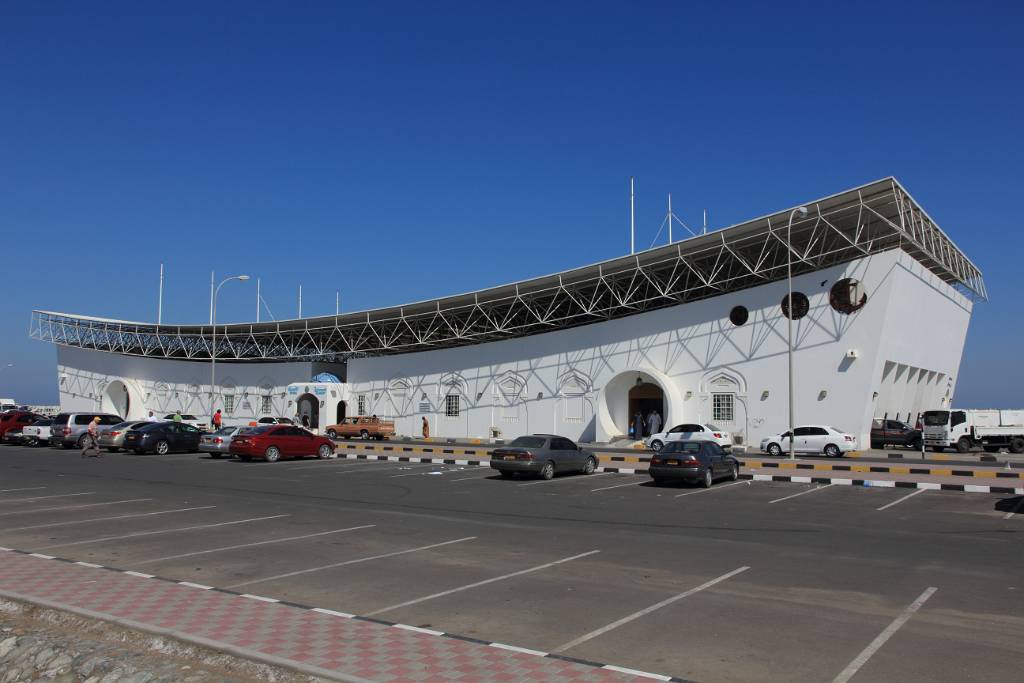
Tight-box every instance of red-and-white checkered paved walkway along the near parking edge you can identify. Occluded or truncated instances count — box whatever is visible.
[0,549,677,683]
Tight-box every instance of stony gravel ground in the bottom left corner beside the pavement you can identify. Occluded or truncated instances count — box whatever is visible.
[0,598,323,683]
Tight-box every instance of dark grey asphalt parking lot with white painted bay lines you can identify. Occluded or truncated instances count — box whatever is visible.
[0,446,1024,681]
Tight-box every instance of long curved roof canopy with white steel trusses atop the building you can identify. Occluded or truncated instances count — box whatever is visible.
[30,177,986,361]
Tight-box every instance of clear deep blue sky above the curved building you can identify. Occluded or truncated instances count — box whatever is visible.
[0,2,1024,407]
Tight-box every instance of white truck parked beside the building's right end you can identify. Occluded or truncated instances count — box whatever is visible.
[924,410,1024,453]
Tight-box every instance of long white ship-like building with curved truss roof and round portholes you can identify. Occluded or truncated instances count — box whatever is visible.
[31,178,986,444]
